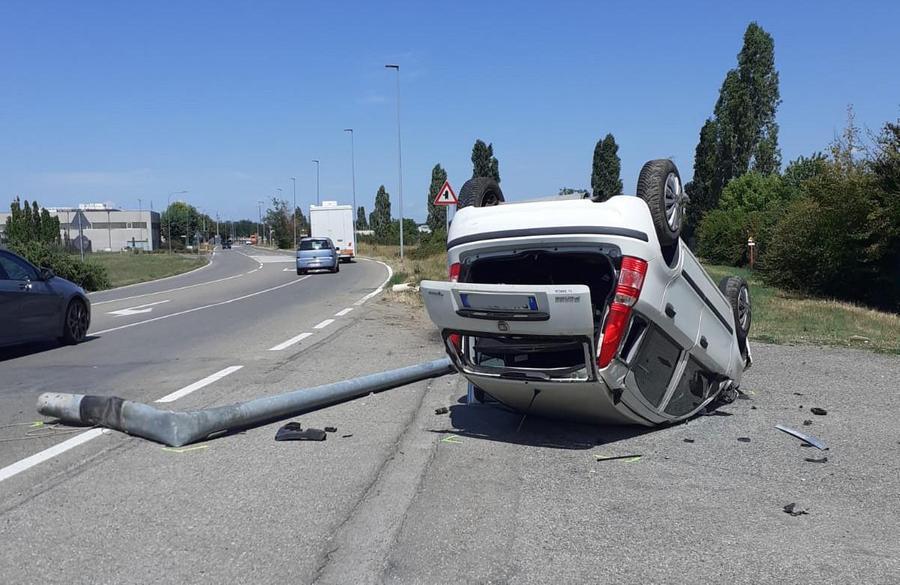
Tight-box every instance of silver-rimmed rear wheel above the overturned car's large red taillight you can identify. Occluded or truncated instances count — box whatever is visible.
[637,159,684,248]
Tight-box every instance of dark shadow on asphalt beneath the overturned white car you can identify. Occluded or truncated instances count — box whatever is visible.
[431,403,656,449]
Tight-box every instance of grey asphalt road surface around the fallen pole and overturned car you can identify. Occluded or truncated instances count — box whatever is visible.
[0,251,900,584]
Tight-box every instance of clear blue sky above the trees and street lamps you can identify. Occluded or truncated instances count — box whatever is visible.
[0,0,900,220]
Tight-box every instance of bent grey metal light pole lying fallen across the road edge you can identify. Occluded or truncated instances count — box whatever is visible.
[38,358,456,447]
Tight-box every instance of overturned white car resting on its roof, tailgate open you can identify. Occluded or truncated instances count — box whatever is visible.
[421,160,751,425]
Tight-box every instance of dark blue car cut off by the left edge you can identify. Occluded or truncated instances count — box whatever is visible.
[0,250,91,345]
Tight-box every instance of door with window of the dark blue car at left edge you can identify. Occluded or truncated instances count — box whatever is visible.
[0,252,62,341]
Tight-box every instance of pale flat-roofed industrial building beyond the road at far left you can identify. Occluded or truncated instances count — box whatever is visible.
[0,203,160,252]
